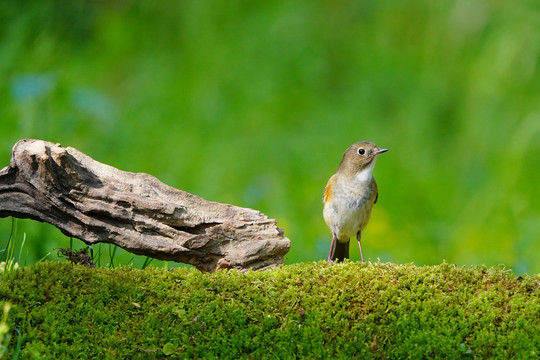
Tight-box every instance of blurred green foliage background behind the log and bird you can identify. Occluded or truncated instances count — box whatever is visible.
[0,0,540,273]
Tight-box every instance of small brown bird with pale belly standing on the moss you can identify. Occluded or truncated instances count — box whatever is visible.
[323,141,388,262]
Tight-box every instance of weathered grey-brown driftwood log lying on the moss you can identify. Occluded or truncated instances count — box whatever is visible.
[0,139,290,271]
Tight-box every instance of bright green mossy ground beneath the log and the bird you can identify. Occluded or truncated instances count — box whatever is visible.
[0,262,540,359]
